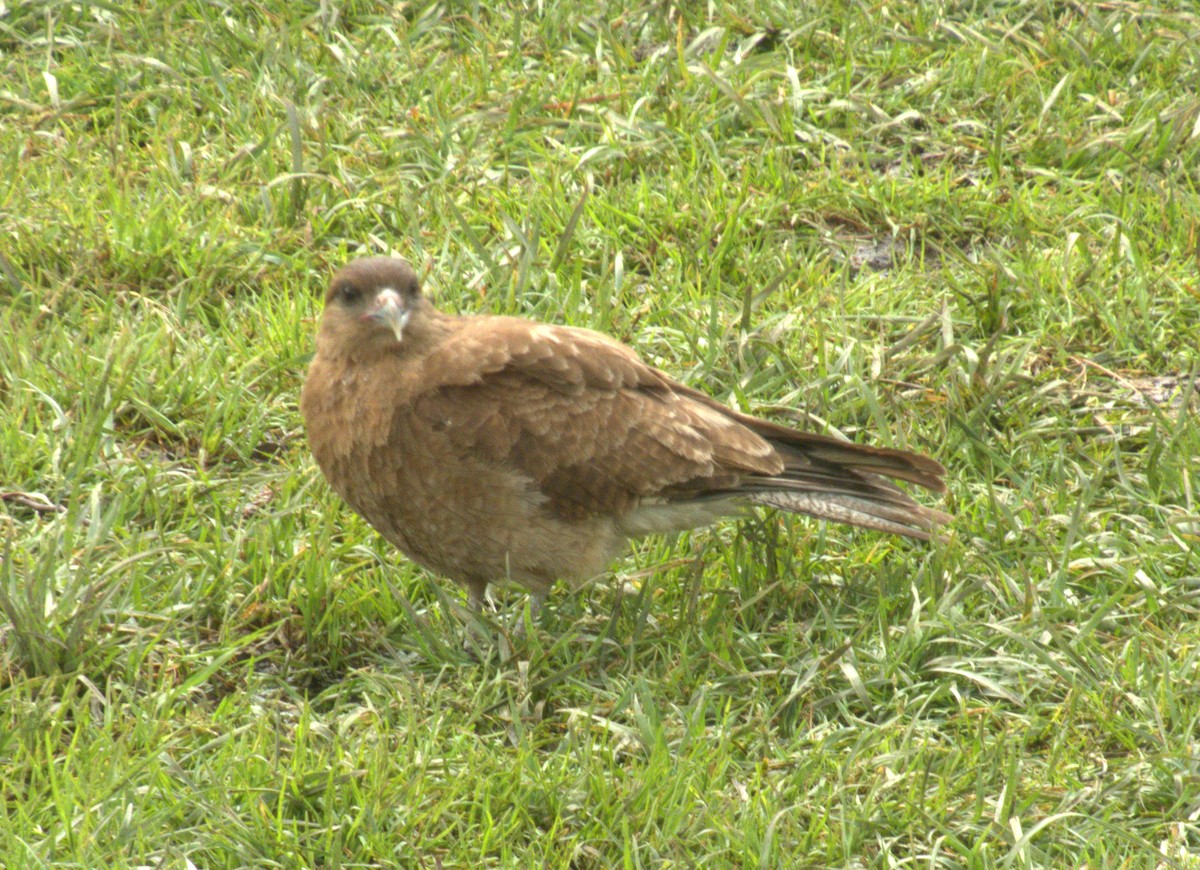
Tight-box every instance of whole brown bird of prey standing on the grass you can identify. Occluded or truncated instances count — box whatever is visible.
[300,257,950,611]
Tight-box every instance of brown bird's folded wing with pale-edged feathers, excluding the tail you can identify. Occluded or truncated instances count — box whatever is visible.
[413,318,784,517]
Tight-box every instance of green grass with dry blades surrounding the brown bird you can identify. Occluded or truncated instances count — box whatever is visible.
[0,0,1200,868]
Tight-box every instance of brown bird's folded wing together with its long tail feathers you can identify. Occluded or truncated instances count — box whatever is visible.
[413,318,948,538]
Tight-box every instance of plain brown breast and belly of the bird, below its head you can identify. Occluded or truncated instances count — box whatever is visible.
[301,350,623,588]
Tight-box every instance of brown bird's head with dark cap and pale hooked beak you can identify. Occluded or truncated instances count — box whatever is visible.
[320,257,427,352]
